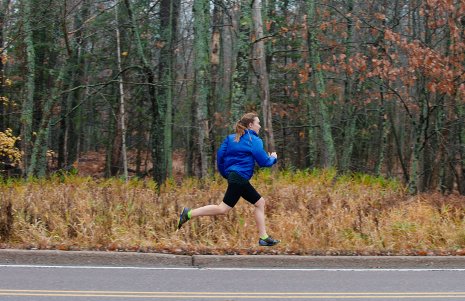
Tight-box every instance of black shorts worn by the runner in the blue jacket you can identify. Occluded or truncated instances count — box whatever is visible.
[223,172,262,208]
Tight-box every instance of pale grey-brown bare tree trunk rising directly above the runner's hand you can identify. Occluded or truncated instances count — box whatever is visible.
[252,0,275,152]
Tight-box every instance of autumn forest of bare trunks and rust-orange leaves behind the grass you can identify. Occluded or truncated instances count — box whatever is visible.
[0,0,465,195]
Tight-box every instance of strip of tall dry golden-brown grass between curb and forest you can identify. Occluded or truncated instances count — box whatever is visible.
[0,170,465,255]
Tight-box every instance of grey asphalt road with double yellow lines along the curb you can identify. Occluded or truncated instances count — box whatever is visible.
[0,264,465,301]
